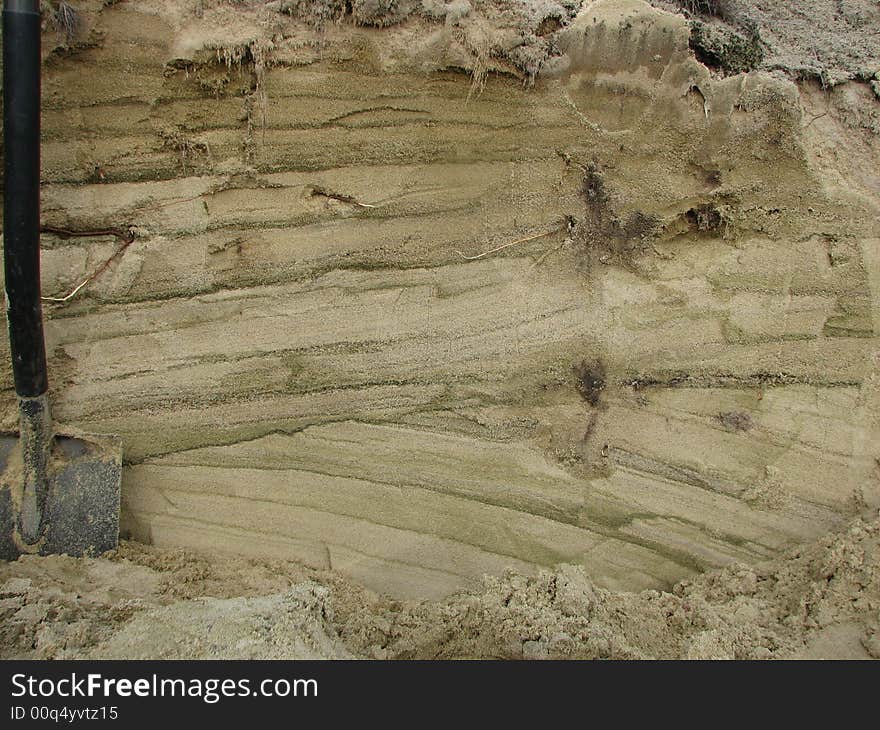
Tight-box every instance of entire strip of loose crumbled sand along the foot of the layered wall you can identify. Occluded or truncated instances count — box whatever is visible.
[0,510,880,659]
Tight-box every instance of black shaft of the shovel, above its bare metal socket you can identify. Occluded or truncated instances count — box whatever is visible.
[3,0,48,398]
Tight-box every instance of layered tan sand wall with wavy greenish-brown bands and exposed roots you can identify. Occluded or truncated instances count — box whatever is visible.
[2,0,880,597]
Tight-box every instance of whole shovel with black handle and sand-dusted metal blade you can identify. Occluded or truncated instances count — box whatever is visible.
[0,0,122,560]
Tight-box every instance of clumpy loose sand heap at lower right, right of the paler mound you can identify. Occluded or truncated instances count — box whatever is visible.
[343,510,880,659]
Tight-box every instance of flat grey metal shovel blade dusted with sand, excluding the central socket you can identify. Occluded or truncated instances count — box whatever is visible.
[0,434,122,560]
